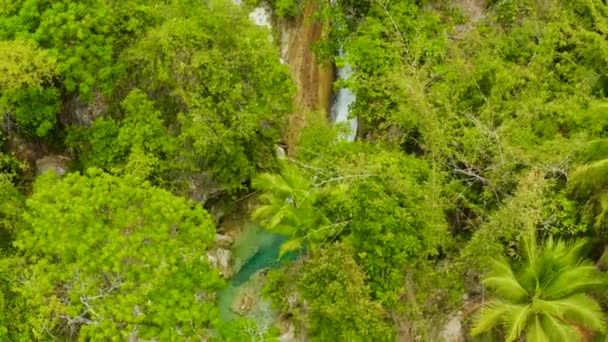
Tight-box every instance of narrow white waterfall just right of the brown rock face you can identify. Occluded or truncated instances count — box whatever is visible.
[331,49,359,141]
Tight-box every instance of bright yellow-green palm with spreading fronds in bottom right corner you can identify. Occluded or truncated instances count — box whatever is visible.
[472,234,606,342]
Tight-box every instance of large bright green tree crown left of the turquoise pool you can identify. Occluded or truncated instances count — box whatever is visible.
[11,169,222,339]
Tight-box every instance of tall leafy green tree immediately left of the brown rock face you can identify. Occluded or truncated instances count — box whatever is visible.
[125,2,293,189]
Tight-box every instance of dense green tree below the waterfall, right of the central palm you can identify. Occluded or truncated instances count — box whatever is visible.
[341,152,446,306]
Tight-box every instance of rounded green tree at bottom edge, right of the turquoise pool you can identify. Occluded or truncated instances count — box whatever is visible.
[264,243,395,341]
